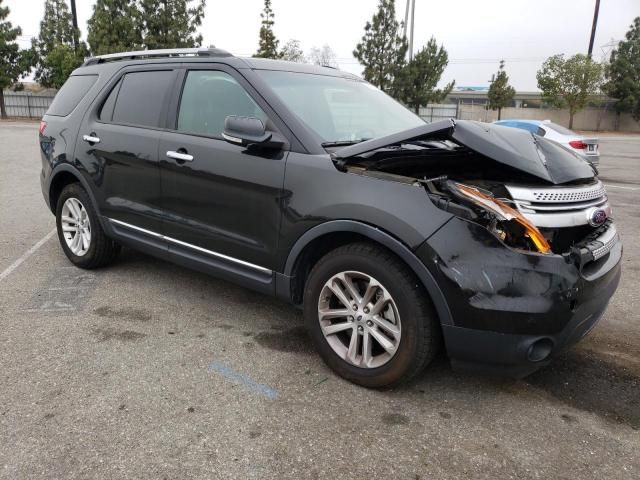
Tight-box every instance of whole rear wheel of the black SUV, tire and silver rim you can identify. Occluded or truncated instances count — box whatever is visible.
[56,183,120,268]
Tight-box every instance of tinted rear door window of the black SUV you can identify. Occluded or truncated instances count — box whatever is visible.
[107,70,174,127]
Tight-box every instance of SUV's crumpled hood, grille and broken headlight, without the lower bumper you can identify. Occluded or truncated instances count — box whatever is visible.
[332,120,617,265]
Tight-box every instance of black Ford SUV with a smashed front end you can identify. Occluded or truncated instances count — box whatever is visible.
[39,49,622,387]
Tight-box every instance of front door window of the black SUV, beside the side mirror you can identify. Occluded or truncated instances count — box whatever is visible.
[176,70,267,138]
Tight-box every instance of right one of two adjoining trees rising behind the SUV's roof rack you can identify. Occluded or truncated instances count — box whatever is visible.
[140,0,205,50]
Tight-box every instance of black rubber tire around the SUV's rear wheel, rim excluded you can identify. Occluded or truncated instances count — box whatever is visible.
[56,183,120,269]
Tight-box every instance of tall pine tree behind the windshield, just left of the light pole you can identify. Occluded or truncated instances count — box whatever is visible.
[353,0,408,97]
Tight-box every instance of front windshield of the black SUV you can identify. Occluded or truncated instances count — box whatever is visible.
[262,70,425,144]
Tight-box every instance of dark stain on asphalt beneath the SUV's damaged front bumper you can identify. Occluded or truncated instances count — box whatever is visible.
[525,351,640,430]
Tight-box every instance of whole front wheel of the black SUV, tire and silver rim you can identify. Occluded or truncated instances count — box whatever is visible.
[304,243,440,387]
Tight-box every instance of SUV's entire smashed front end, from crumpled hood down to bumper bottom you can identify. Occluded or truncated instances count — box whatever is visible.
[332,121,622,376]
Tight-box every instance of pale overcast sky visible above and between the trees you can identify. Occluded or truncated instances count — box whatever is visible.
[4,0,640,91]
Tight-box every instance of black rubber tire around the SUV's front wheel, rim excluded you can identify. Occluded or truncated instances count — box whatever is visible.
[304,243,441,388]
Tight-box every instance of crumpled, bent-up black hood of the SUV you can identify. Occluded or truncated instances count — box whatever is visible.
[332,120,597,185]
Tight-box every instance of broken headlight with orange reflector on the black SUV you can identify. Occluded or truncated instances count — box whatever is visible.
[446,181,551,253]
